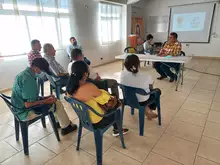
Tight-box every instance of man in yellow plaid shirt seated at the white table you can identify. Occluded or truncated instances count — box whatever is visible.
[154,32,182,82]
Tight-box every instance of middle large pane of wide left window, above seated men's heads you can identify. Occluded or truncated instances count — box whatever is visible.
[27,16,58,48]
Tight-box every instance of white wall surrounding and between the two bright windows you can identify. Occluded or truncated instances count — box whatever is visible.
[0,0,127,90]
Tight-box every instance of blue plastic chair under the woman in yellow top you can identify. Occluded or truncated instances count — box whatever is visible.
[64,96,126,165]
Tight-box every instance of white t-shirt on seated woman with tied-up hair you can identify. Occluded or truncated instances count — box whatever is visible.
[120,68,153,102]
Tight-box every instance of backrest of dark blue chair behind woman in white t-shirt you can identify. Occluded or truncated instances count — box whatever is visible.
[119,84,147,108]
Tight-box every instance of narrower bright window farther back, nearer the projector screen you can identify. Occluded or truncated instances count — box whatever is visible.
[100,3,122,45]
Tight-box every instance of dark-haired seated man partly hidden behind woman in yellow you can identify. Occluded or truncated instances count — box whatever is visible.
[68,49,119,99]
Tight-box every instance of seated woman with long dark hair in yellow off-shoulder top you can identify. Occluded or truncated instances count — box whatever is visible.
[66,61,128,136]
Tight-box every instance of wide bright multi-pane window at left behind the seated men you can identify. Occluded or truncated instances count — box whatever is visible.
[0,0,71,56]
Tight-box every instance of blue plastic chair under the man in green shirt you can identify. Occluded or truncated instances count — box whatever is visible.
[0,93,60,155]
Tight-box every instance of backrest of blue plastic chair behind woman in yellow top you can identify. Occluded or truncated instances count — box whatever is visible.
[64,96,93,131]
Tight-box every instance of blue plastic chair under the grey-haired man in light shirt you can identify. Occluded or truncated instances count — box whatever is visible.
[46,72,68,99]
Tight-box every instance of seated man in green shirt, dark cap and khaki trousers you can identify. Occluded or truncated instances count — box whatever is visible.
[11,58,77,135]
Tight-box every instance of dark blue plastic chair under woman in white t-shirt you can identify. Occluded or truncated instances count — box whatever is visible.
[119,84,161,136]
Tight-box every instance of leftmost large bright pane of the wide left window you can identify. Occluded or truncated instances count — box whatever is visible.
[0,15,30,55]
